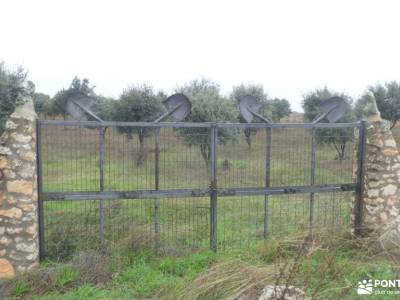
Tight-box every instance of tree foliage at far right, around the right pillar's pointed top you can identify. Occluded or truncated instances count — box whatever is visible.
[355,81,400,128]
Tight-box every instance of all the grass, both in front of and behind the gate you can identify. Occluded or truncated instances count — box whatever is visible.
[0,126,399,300]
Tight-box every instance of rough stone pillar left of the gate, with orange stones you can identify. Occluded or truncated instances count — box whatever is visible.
[0,92,39,278]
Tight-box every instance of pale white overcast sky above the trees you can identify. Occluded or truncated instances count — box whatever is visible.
[0,0,400,111]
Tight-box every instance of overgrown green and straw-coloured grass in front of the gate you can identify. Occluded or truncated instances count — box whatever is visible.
[0,232,400,300]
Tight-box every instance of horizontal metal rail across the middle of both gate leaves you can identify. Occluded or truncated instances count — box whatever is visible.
[41,184,356,201]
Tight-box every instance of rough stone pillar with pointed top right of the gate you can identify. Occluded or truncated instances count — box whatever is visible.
[354,94,400,249]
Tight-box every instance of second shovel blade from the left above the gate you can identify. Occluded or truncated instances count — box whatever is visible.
[154,93,192,123]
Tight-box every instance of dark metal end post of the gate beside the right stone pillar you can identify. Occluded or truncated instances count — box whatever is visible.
[354,121,367,235]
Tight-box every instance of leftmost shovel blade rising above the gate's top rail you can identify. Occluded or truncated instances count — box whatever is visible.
[65,92,103,122]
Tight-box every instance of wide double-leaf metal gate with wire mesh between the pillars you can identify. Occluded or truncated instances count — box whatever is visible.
[37,121,362,258]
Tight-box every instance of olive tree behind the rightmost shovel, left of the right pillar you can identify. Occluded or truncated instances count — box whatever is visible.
[302,87,355,161]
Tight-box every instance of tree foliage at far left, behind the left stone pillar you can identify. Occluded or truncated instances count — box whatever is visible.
[0,62,26,135]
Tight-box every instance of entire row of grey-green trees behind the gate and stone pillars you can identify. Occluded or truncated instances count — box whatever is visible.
[0,63,400,163]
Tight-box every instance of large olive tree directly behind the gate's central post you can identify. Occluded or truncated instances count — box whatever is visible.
[177,79,238,166]
